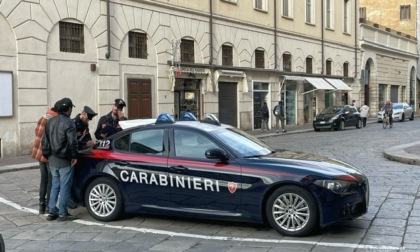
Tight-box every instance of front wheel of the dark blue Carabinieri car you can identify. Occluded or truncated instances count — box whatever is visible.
[266,186,318,236]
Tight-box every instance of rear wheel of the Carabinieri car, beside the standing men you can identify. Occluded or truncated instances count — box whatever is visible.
[85,177,124,222]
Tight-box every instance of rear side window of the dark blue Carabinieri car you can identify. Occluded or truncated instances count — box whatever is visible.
[114,129,164,155]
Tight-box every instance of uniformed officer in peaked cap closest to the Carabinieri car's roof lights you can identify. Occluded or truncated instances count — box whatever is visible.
[95,99,127,140]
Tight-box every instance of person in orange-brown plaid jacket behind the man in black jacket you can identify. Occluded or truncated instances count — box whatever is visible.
[31,107,58,214]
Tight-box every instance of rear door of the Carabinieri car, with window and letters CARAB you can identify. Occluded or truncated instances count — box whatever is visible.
[109,128,170,208]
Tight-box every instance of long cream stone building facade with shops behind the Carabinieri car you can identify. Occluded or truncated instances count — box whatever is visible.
[0,0,411,157]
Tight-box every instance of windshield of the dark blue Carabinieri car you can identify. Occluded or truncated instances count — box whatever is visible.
[212,128,273,157]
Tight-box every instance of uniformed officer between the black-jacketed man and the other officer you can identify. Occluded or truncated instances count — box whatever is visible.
[73,106,97,150]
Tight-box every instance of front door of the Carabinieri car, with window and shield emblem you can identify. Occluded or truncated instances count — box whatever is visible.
[168,128,241,216]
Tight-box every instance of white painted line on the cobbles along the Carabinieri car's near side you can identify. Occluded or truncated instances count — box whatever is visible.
[0,197,404,250]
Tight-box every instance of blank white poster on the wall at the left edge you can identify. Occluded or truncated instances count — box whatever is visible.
[0,72,13,117]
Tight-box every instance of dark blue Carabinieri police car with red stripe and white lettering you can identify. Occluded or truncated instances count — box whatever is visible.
[73,114,369,236]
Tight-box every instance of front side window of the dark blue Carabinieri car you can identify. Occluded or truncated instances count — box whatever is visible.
[174,129,218,158]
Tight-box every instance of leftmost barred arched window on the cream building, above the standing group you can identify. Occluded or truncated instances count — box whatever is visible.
[59,22,85,53]
